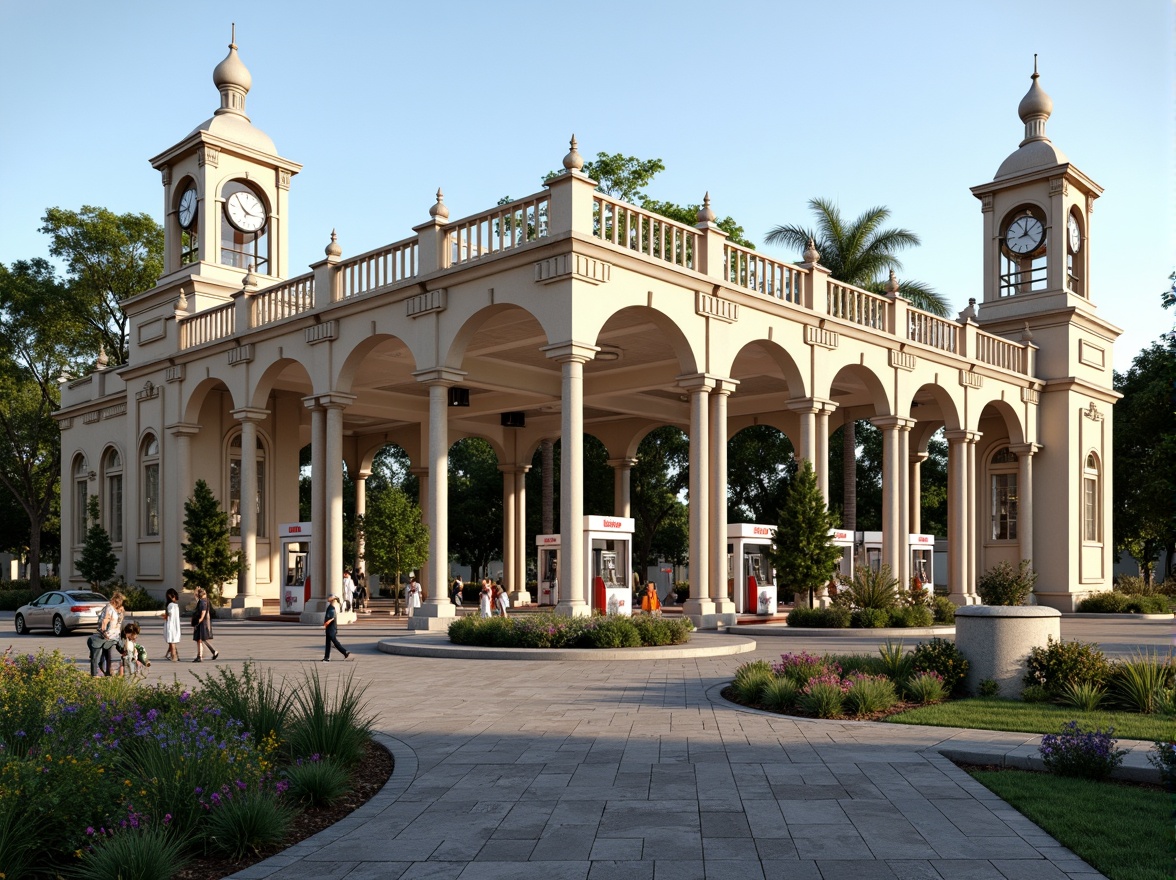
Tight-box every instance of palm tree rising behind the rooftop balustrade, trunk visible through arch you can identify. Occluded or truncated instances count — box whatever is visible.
[766,199,948,531]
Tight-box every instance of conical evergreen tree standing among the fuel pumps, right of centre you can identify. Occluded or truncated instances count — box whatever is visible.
[771,459,841,605]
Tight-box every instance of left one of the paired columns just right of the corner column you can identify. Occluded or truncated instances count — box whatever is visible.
[677,373,715,628]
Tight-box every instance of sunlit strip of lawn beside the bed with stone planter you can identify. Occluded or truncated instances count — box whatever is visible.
[884,696,1172,741]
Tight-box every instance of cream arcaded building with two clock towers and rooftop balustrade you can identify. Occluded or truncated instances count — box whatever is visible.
[58,39,1120,628]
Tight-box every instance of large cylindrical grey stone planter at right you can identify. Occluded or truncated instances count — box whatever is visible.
[956,605,1062,700]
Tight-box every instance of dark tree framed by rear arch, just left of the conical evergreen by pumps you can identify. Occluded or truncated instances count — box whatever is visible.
[727,425,794,522]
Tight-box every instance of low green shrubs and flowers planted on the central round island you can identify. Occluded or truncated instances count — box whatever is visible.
[449,614,694,648]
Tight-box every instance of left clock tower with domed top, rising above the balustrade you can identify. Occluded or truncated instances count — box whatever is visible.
[151,33,301,291]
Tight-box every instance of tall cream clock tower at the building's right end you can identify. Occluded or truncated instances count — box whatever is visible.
[971,59,1121,611]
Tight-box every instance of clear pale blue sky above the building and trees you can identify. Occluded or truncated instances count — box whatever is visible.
[0,0,1176,369]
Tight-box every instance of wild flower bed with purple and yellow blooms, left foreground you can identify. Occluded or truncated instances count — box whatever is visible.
[0,651,372,880]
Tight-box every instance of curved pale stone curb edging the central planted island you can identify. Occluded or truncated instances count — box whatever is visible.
[375,633,756,662]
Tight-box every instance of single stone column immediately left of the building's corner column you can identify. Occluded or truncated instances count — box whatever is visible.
[408,369,465,631]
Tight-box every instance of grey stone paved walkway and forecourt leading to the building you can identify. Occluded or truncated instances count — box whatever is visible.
[4,618,1171,880]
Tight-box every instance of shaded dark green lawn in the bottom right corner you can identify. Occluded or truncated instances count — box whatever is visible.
[968,769,1174,880]
